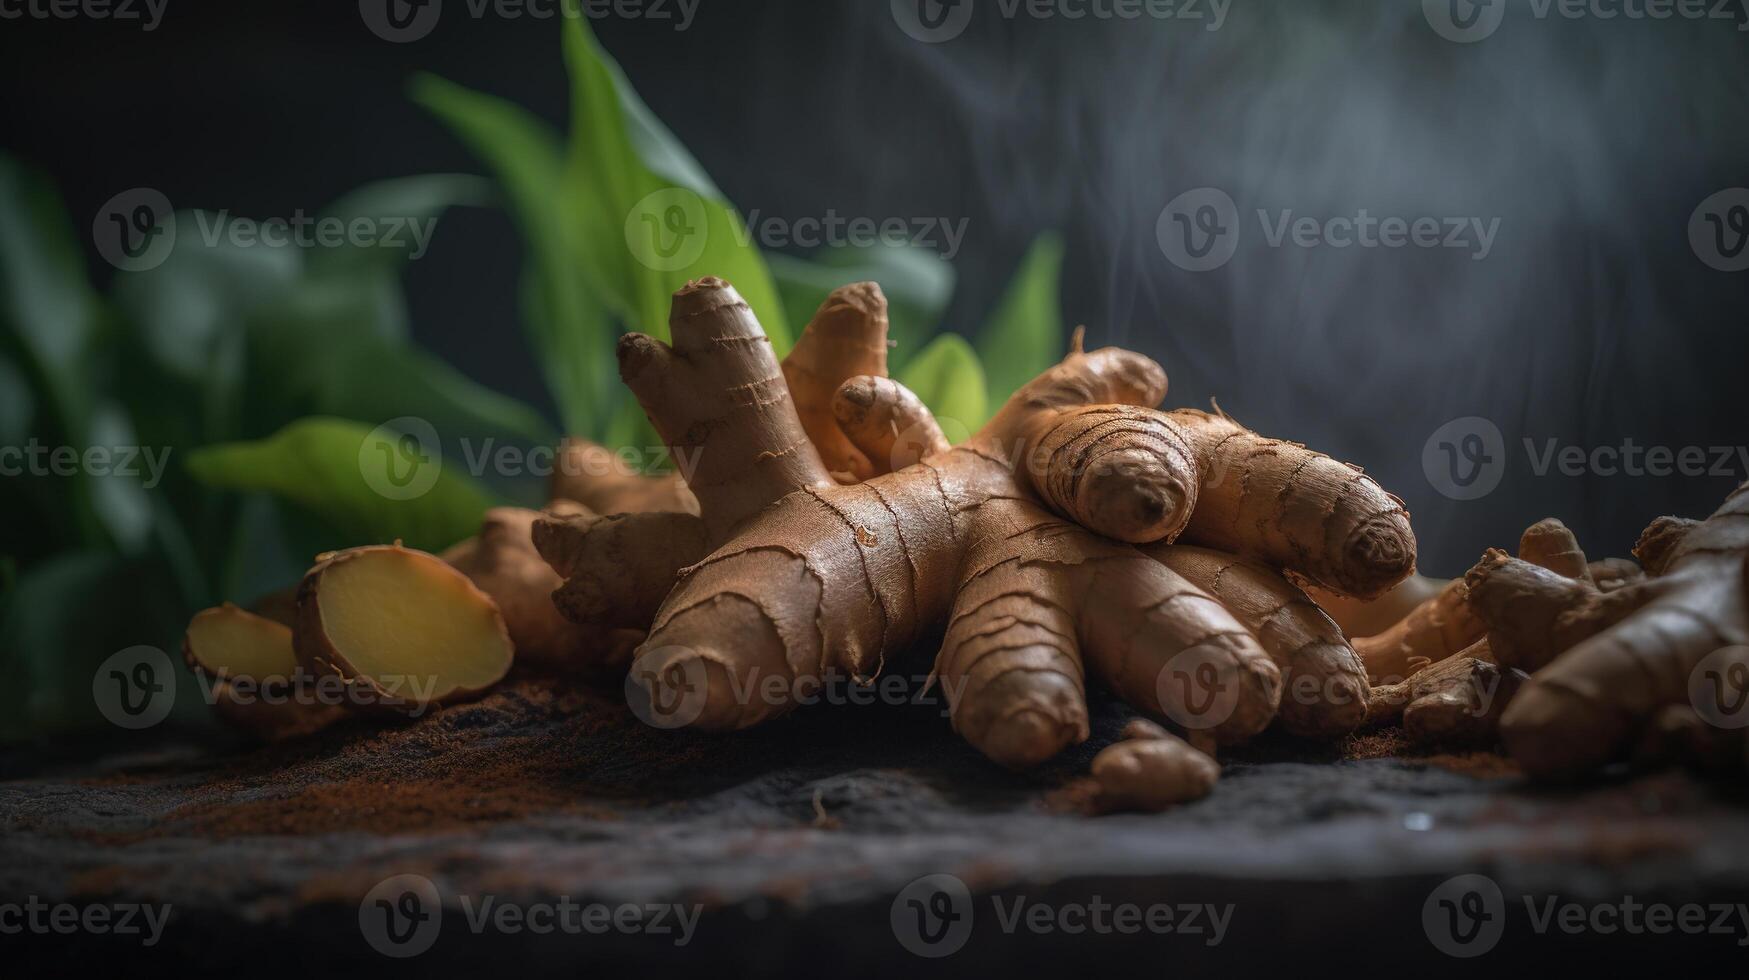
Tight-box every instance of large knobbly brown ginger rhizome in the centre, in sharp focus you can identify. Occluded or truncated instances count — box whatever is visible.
[533,278,1415,767]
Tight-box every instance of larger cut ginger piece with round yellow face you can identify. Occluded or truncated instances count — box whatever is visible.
[294,543,514,714]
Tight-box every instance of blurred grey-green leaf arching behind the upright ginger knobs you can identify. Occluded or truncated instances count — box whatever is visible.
[766,245,953,366]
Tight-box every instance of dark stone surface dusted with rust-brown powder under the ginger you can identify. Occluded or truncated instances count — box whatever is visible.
[0,683,1749,977]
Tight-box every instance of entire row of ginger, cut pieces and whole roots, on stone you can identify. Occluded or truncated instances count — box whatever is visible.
[184,278,1749,810]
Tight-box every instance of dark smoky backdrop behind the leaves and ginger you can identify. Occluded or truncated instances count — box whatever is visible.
[0,0,1749,574]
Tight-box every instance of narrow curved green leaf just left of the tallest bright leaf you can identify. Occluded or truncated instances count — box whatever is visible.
[413,75,619,434]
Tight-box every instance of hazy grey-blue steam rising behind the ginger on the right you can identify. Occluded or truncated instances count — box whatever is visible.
[850,0,1749,574]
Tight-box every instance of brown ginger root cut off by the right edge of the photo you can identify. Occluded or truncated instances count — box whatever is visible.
[1466,483,1749,777]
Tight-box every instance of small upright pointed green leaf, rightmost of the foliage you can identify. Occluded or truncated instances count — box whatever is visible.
[978,235,1069,406]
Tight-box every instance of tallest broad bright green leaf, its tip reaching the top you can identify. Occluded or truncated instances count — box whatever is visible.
[563,18,791,355]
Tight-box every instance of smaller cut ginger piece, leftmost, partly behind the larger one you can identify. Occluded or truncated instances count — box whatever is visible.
[182,602,345,742]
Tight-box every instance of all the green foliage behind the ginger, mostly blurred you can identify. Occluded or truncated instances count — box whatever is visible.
[0,18,1065,740]
